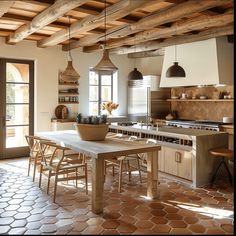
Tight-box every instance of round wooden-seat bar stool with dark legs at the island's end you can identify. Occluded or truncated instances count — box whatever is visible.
[210,148,234,185]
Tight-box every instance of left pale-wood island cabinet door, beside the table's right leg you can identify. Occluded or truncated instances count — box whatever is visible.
[162,147,178,175]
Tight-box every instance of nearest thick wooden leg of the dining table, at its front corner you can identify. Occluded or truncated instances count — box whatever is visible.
[92,157,104,214]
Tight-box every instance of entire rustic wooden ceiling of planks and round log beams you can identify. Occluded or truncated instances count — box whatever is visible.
[0,0,234,57]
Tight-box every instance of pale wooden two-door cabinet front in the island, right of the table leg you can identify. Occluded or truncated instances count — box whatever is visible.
[158,146,192,180]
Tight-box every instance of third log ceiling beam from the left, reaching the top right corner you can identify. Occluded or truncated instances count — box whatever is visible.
[65,0,232,51]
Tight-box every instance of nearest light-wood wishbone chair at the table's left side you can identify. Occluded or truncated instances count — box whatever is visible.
[39,141,88,202]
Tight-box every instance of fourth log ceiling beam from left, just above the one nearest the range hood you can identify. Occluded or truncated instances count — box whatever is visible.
[106,9,234,49]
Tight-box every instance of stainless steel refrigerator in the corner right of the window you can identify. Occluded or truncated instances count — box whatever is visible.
[128,75,171,122]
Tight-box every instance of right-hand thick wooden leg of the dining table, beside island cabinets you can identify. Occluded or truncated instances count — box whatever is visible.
[147,152,158,198]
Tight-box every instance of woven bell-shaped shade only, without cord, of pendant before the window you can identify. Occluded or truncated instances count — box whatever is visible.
[93,49,118,72]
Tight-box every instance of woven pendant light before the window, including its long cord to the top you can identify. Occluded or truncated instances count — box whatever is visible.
[92,0,118,72]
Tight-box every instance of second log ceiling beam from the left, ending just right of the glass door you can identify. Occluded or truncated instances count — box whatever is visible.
[38,0,159,47]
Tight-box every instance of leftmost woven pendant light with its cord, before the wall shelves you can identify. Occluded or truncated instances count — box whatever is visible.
[61,16,80,83]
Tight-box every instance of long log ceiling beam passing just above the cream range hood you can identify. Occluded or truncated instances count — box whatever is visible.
[109,24,234,55]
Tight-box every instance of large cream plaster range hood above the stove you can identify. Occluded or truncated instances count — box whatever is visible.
[160,36,234,87]
